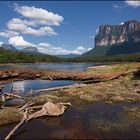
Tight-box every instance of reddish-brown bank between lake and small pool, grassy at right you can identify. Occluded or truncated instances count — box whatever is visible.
[0,63,140,84]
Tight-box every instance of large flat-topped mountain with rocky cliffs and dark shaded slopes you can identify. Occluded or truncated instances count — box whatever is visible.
[82,20,140,56]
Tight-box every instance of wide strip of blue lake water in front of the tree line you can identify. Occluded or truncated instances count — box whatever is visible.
[0,63,99,71]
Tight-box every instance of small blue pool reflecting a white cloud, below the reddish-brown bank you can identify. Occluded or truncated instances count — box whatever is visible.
[1,80,76,96]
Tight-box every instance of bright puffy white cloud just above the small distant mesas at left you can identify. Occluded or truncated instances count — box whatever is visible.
[8,36,36,47]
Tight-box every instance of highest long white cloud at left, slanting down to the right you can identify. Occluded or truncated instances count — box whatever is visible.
[15,4,64,26]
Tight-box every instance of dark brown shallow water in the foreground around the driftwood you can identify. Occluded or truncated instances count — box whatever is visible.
[0,103,140,139]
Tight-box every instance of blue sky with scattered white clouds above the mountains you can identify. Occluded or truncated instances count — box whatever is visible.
[0,0,140,55]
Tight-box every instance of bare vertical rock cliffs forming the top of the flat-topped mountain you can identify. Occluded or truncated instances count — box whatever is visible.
[95,20,140,46]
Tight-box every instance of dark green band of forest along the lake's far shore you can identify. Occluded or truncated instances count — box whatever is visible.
[0,48,140,63]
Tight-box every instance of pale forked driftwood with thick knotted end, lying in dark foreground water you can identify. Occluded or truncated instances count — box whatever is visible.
[5,102,71,140]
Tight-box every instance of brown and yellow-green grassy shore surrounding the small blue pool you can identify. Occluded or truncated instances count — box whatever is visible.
[0,63,140,126]
